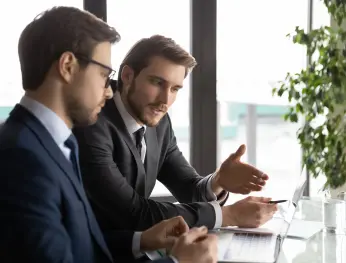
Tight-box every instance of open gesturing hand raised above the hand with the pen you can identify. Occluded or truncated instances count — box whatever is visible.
[212,144,269,194]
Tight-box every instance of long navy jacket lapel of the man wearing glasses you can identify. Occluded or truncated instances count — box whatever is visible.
[11,105,112,259]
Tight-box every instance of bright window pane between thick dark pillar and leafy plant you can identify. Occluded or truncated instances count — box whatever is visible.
[217,0,308,202]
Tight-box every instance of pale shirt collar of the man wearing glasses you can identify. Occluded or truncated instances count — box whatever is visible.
[20,96,71,145]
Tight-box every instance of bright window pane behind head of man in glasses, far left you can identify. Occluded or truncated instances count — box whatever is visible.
[0,0,83,122]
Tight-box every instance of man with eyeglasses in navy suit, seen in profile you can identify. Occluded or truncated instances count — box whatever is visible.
[0,7,216,263]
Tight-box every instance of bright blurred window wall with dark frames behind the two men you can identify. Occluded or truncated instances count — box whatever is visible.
[0,0,330,200]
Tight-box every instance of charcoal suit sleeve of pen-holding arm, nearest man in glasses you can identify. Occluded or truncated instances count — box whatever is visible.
[74,116,215,231]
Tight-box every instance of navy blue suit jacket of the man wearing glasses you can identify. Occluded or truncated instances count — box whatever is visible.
[0,105,172,263]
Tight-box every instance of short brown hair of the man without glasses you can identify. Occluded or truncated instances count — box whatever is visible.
[116,35,197,91]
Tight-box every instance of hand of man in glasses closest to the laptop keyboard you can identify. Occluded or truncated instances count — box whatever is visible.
[171,227,217,263]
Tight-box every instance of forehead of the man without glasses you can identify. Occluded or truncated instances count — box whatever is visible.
[141,56,186,85]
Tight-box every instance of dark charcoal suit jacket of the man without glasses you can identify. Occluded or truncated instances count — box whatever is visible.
[74,97,219,231]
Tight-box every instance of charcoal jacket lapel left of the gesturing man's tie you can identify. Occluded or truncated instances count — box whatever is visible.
[103,99,146,196]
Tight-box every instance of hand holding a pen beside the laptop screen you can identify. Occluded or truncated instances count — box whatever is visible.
[222,196,278,227]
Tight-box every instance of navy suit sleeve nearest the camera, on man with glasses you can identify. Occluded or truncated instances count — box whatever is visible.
[0,149,73,263]
